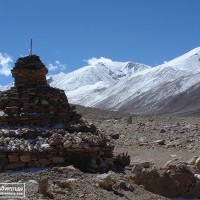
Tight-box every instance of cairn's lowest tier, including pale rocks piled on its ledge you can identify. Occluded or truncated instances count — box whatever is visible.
[0,126,114,172]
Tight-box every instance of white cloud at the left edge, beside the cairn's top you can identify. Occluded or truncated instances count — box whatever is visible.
[0,53,13,76]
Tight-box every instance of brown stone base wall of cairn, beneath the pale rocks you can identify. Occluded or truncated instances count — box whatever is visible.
[0,147,113,172]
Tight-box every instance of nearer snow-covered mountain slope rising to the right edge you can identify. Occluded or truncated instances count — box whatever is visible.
[91,48,200,114]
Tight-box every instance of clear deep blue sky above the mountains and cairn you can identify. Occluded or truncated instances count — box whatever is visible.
[0,0,200,85]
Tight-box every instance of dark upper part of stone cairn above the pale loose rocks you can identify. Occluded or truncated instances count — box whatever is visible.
[0,55,80,126]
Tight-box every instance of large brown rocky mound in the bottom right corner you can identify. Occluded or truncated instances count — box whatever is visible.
[132,164,200,198]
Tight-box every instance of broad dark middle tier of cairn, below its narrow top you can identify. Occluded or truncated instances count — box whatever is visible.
[0,87,81,126]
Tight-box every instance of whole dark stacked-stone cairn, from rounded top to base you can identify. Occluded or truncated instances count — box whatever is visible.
[0,55,114,172]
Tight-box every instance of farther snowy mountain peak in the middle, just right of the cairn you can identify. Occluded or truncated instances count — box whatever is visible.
[49,58,149,106]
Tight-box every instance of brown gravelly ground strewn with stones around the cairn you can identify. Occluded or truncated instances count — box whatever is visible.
[0,106,200,200]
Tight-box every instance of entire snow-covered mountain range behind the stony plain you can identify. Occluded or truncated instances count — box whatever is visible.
[0,47,200,115]
